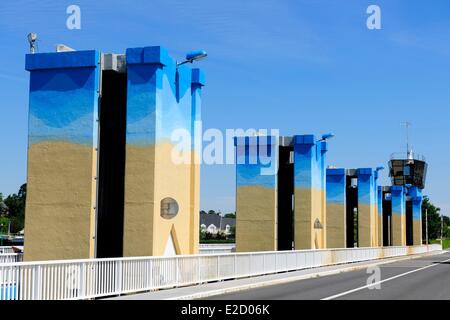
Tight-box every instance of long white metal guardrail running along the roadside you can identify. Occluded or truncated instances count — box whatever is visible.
[0,245,441,300]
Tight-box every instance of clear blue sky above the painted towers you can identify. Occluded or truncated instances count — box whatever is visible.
[0,0,450,214]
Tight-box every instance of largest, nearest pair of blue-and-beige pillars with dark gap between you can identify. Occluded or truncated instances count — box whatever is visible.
[24,46,205,261]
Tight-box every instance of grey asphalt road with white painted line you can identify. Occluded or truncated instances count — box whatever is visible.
[210,252,450,300]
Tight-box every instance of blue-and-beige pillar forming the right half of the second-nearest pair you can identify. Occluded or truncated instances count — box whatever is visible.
[294,135,327,249]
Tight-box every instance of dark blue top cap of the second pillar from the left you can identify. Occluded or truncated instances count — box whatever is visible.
[126,46,174,66]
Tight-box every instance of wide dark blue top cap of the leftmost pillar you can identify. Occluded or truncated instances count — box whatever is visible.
[25,50,99,71]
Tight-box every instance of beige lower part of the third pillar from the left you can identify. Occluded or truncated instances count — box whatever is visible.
[236,186,277,252]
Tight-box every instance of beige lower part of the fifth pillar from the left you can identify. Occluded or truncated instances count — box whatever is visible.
[327,203,347,248]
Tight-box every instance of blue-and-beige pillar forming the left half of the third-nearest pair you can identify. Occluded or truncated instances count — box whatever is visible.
[326,169,347,248]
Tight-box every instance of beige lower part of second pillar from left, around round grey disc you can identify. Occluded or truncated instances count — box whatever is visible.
[124,143,199,256]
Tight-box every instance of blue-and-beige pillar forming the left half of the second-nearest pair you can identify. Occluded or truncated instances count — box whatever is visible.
[235,137,278,252]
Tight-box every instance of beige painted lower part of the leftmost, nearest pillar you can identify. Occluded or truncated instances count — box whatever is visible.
[24,141,97,261]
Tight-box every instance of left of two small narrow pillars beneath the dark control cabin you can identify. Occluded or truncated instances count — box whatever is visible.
[391,186,406,246]
